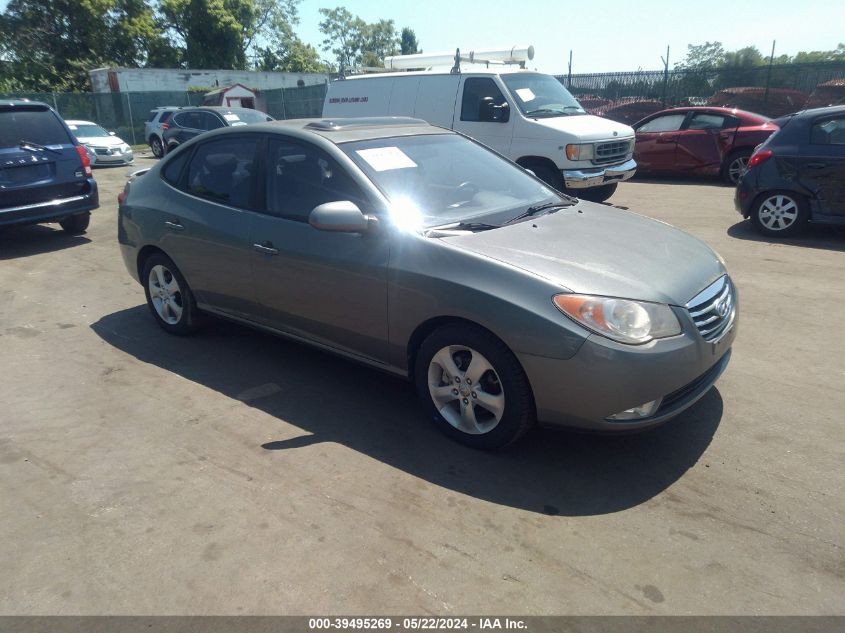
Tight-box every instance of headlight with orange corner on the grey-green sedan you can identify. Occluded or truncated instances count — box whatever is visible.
[553,295,681,345]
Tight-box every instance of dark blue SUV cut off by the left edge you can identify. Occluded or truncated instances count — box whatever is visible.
[0,100,100,235]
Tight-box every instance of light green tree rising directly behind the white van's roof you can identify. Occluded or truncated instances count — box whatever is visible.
[320,7,399,70]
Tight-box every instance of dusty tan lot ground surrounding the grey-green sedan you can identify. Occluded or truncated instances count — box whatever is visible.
[0,158,845,614]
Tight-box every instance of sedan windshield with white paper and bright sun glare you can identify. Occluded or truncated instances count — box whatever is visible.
[340,134,569,229]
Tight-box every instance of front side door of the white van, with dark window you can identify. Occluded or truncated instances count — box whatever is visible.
[453,77,513,156]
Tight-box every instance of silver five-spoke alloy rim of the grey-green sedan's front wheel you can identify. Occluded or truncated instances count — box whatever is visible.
[428,345,505,435]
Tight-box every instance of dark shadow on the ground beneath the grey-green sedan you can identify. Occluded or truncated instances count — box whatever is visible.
[91,305,722,516]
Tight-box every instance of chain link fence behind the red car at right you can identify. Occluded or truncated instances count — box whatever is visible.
[557,62,845,123]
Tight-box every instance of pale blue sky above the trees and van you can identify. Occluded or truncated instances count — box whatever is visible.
[297,0,845,74]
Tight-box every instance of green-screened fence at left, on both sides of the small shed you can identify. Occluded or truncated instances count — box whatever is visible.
[0,84,327,145]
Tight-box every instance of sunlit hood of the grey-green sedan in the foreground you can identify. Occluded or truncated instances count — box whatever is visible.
[441,201,725,305]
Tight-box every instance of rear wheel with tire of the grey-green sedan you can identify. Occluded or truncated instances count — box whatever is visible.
[141,253,198,336]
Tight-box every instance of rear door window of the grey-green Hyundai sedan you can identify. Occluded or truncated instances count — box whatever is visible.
[187,135,258,209]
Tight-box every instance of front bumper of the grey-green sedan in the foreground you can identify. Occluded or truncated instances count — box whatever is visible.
[517,308,738,432]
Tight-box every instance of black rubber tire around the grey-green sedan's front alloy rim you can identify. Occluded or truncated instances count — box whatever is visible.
[414,324,536,450]
